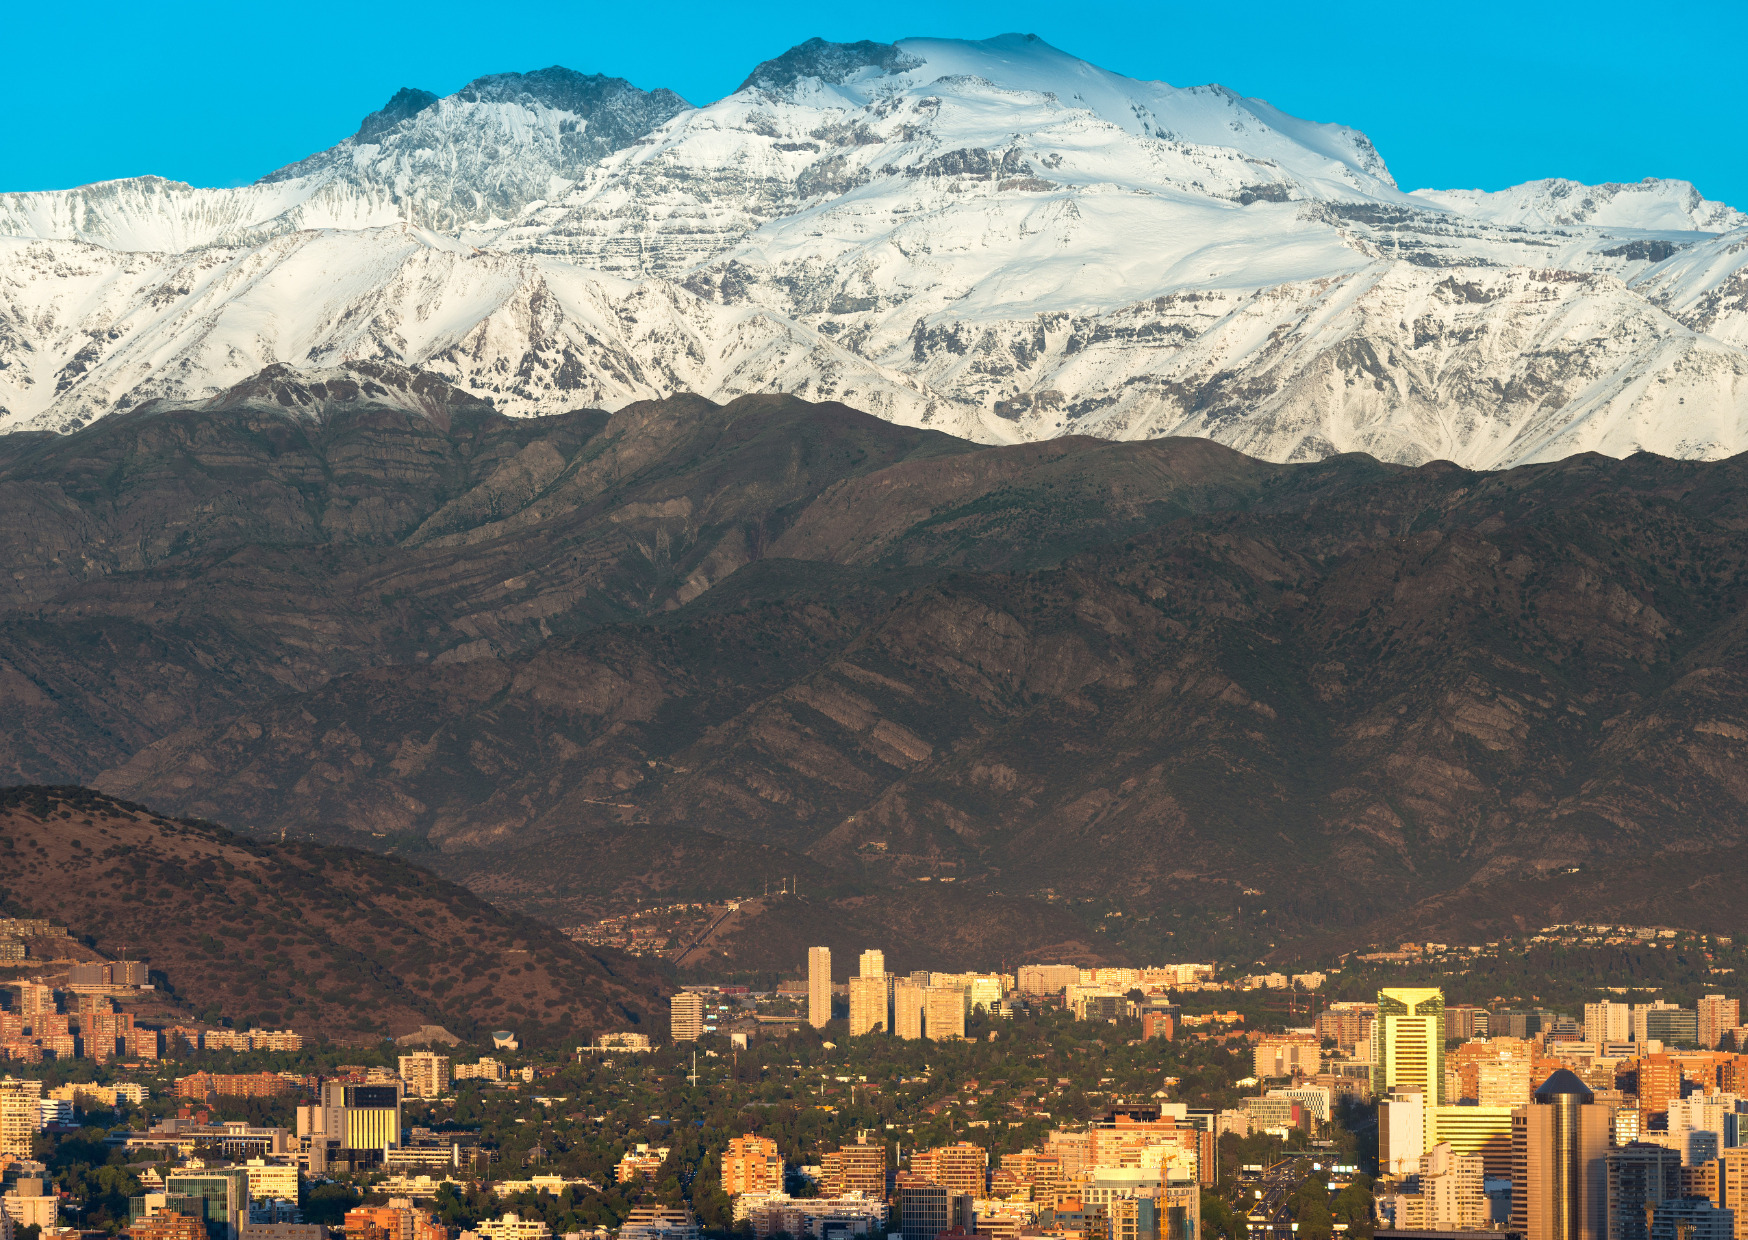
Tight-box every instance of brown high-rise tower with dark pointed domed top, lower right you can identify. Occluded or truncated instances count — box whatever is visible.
[1512,1069,1613,1240]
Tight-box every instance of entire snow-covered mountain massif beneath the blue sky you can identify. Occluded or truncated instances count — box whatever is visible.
[0,35,1748,465]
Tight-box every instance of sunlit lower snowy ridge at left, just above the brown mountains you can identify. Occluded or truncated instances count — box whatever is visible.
[0,224,930,435]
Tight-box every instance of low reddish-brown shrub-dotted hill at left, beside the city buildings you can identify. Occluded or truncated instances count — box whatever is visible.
[0,787,661,1042]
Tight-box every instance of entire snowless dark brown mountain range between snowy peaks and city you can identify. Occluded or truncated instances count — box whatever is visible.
[0,377,1748,943]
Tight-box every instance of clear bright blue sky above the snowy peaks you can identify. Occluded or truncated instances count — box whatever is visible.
[0,0,1748,210]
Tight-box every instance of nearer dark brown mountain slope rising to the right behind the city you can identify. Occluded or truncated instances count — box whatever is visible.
[95,458,1748,943]
